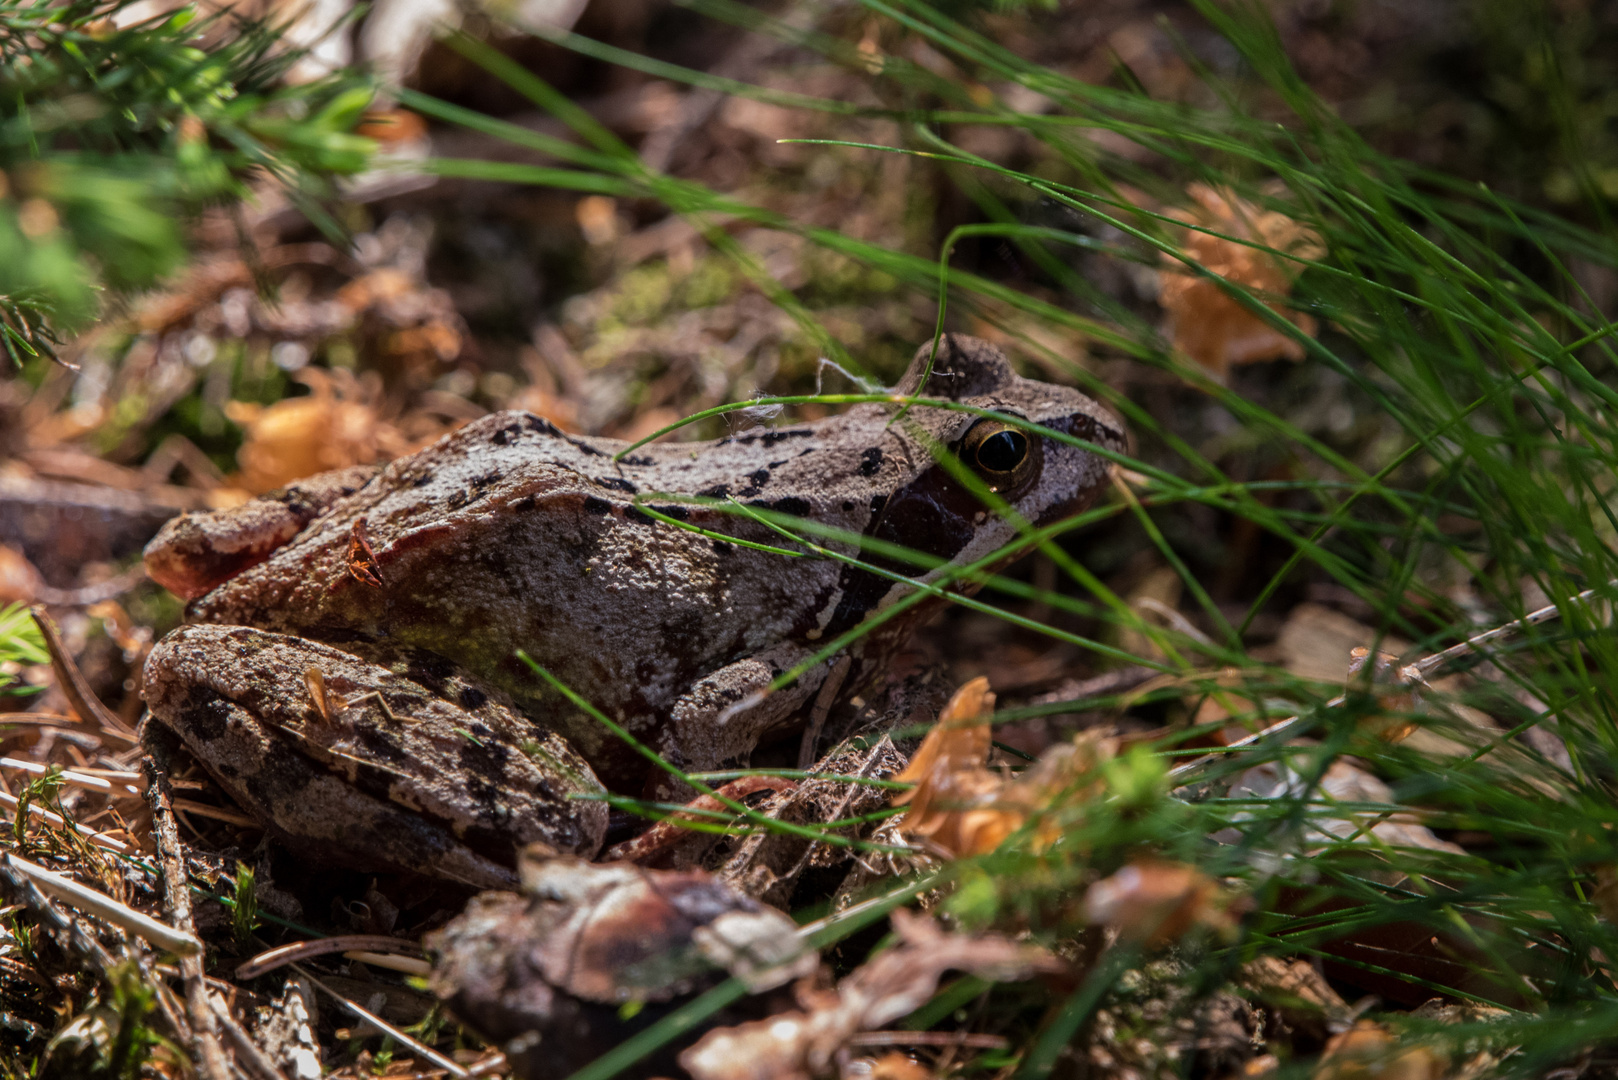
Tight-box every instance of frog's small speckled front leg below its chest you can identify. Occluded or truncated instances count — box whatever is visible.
[667,641,835,772]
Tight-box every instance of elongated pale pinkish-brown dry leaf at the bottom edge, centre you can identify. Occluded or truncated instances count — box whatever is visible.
[680,910,1063,1080]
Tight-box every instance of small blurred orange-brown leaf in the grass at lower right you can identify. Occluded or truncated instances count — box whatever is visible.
[1084,858,1236,949]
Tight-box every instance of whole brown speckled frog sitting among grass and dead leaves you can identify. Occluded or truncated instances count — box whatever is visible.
[146,337,1123,886]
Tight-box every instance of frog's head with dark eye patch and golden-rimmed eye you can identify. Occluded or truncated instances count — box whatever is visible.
[828,334,1126,631]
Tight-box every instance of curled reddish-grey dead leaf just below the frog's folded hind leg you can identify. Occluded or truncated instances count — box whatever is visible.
[426,844,819,1080]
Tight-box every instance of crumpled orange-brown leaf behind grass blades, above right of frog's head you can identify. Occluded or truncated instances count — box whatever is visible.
[1158,183,1325,377]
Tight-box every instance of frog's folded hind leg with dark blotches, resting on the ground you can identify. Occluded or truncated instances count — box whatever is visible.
[146,625,607,887]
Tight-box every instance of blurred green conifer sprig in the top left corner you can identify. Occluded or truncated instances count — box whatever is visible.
[0,0,375,351]
